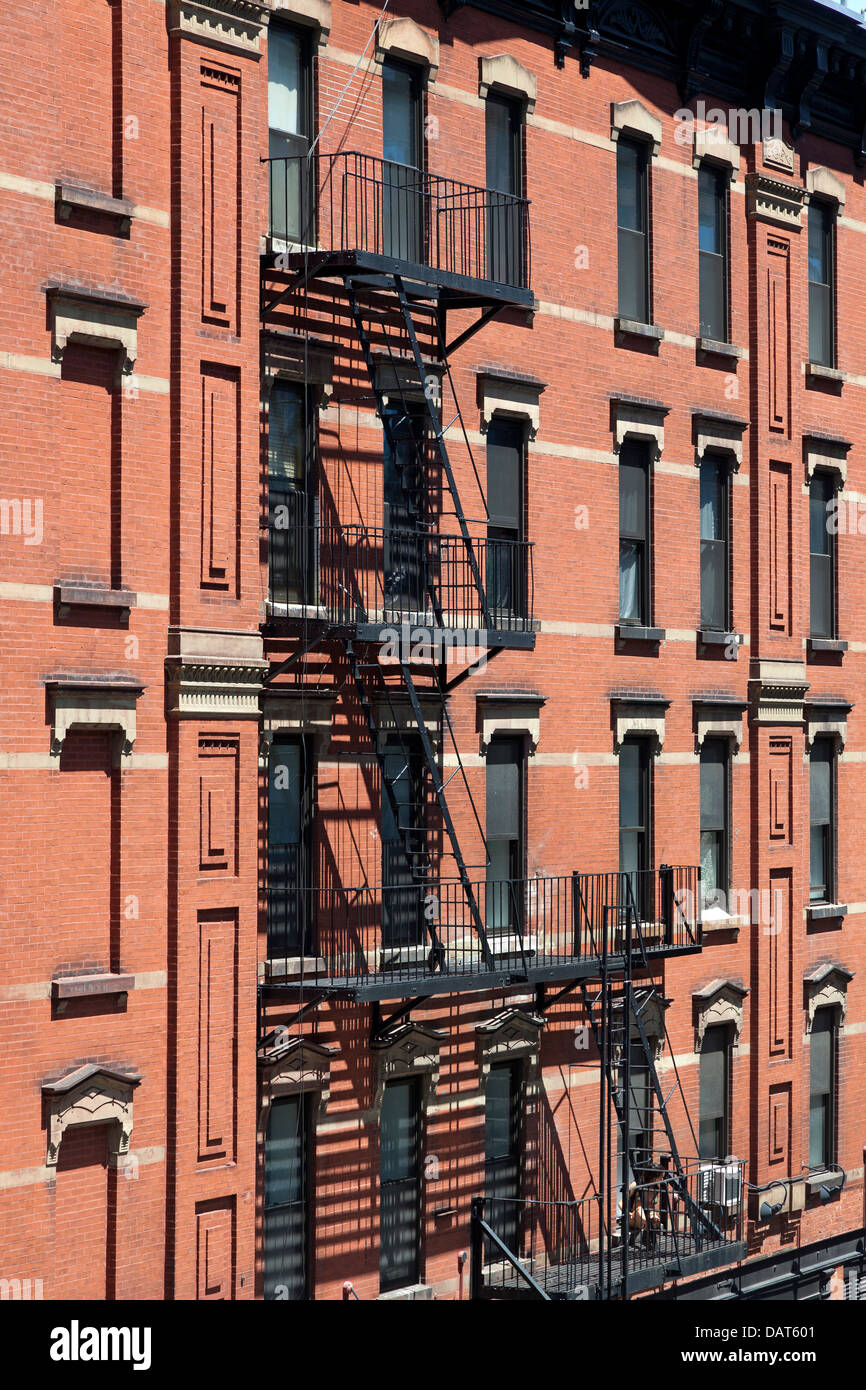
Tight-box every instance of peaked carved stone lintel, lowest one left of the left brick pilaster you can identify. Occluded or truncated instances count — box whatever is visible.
[42,1063,142,1168]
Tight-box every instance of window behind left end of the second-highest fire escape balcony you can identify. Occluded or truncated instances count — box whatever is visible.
[268,381,316,605]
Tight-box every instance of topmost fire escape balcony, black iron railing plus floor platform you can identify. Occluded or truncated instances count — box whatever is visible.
[265,150,532,307]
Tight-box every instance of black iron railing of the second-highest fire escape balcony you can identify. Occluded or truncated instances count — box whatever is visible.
[268,511,534,632]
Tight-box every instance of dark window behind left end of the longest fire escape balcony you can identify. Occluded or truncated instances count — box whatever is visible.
[267,738,313,958]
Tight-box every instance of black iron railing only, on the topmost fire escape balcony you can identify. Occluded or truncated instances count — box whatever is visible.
[267,150,530,289]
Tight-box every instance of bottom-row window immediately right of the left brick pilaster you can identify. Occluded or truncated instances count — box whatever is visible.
[264,1095,313,1300]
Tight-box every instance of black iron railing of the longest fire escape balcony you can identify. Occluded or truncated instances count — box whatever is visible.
[267,860,701,988]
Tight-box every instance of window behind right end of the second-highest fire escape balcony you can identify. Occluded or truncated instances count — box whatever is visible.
[487,418,527,627]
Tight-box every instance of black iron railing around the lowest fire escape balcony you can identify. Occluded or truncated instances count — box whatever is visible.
[471,1158,744,1298]
